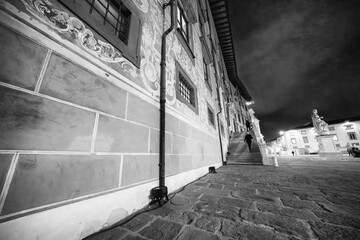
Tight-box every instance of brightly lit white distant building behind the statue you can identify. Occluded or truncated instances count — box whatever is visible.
[270,116,360,155]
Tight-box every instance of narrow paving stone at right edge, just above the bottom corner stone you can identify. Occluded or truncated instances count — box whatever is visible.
[314,211,360,228]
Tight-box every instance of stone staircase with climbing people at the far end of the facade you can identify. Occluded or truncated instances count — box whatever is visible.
[226,131,263,165]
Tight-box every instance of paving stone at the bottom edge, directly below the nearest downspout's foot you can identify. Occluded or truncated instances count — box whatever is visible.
[139,219,182,240]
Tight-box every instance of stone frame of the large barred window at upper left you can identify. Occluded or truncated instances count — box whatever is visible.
[60,0,143,68]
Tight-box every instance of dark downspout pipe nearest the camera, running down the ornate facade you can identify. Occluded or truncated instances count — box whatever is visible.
[150,0,177,205]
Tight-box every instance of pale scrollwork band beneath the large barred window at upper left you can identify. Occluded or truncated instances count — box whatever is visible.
[21,0,136,76]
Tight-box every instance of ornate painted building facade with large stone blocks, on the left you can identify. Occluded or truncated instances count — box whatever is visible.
[0,0,251,240]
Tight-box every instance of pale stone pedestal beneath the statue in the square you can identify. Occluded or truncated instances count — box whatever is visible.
[316,134,342,160]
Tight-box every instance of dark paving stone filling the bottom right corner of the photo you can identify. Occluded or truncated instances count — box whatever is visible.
[310,222,360,240]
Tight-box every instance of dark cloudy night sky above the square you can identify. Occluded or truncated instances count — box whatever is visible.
[228,0,360,141]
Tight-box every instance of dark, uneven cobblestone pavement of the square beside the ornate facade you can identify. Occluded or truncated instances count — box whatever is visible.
[87,158,360,240]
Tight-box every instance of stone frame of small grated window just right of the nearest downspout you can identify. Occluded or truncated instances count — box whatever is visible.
[175,62,199,114]
